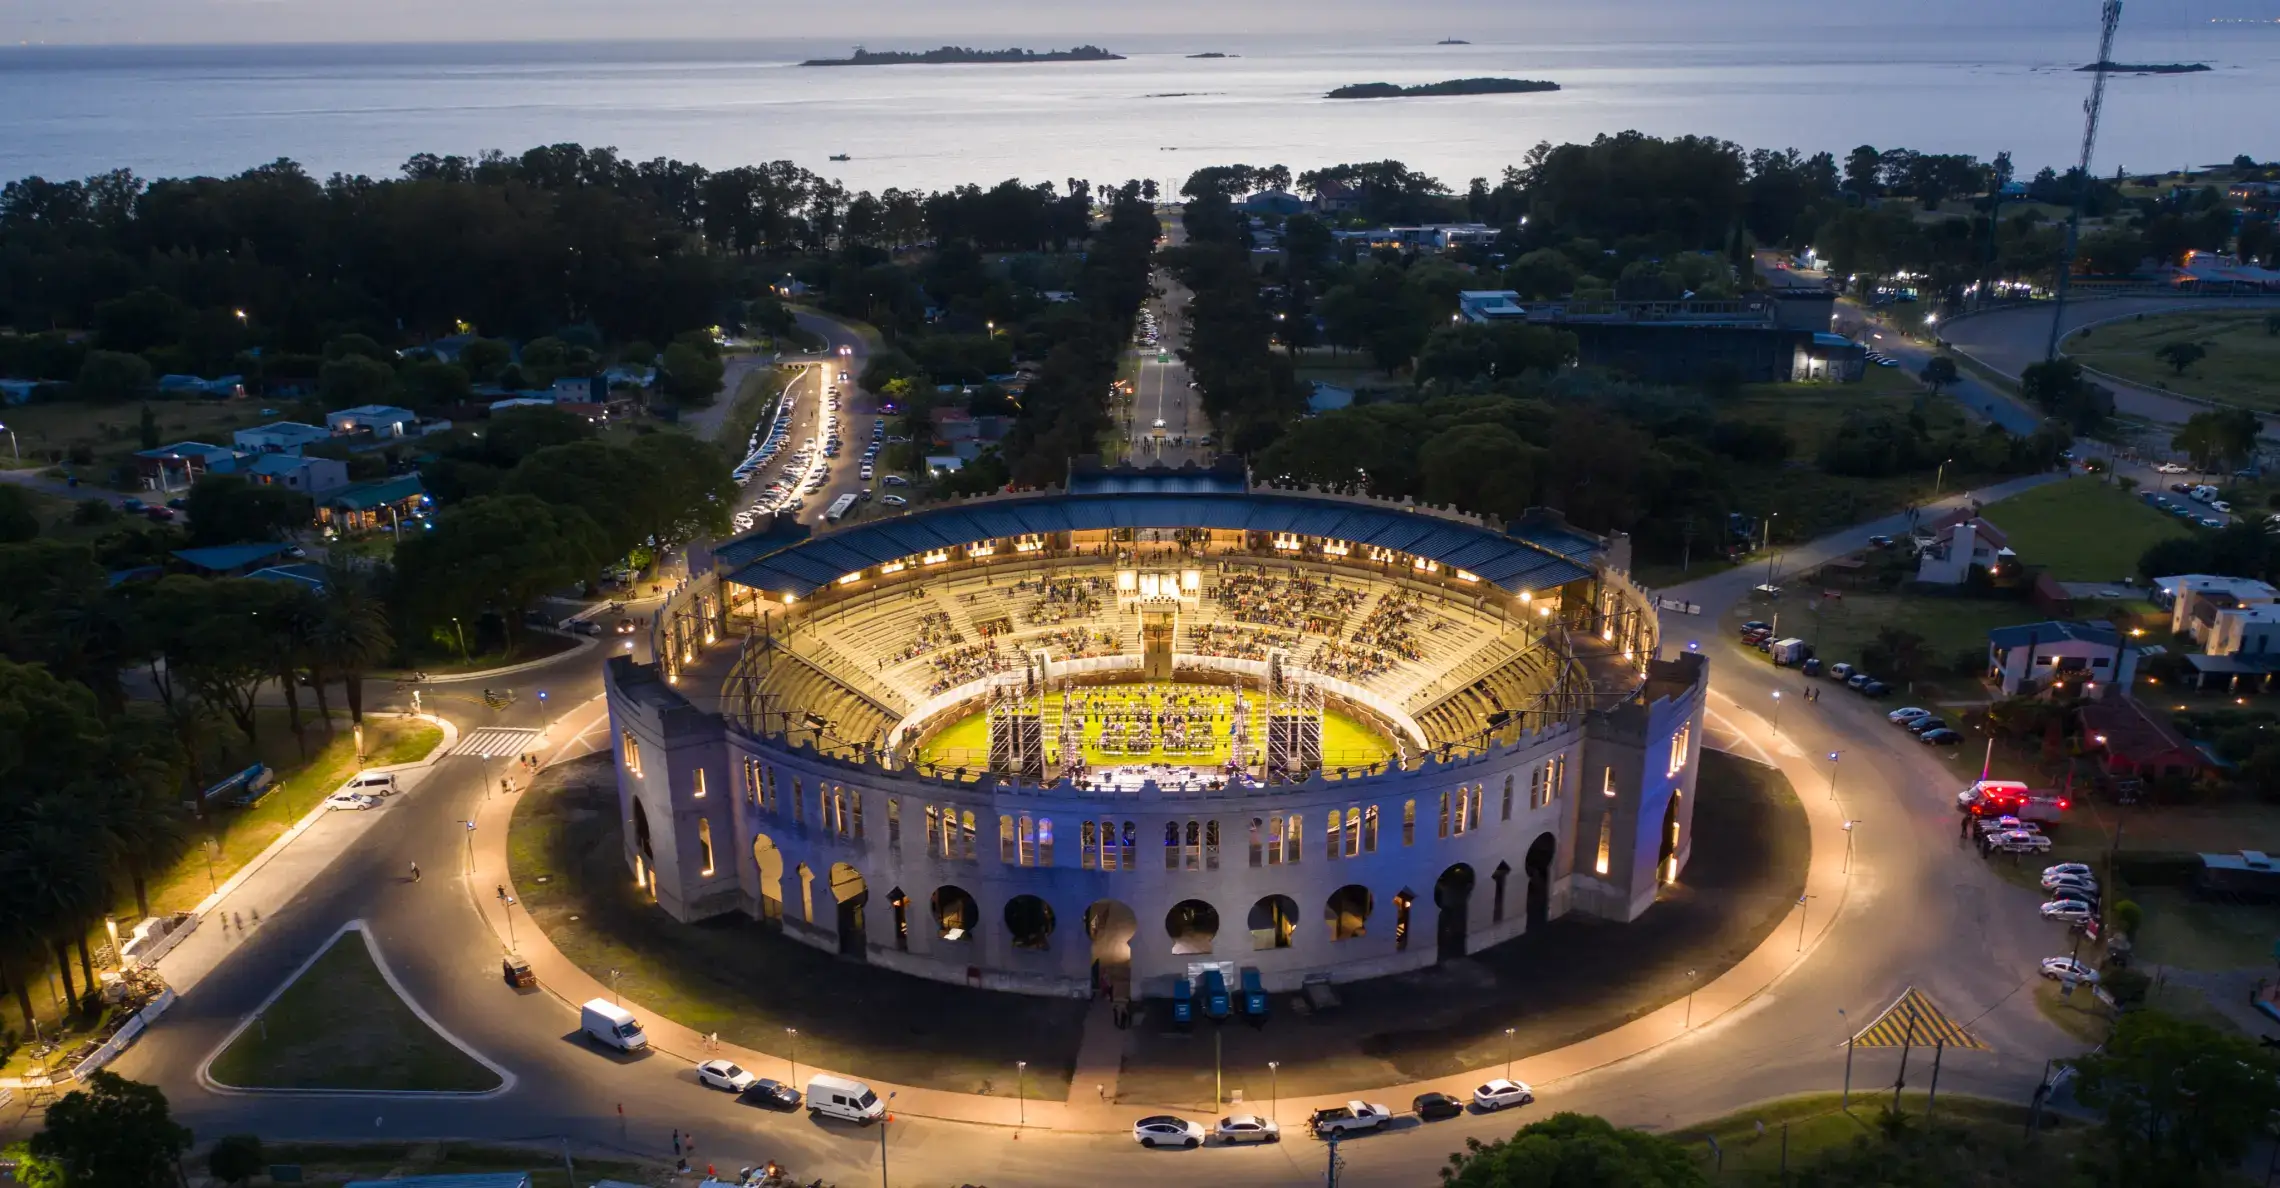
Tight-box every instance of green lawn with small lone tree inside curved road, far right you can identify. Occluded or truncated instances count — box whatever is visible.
[2066,310,2280,410]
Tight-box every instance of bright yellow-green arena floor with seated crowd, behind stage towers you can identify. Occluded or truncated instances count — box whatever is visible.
[917,682,1393,775]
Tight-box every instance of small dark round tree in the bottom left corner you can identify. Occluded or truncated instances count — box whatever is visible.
[30,1069,189,1188]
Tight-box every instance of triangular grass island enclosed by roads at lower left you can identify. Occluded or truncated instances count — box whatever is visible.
[207,933,499,1092]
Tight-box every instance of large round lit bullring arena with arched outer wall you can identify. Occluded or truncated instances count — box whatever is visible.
[606,465,1705,996]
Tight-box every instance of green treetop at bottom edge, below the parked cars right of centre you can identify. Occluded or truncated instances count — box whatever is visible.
[1441,1113,1710,1188]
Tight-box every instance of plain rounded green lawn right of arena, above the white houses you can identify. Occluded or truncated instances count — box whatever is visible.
[1981,477,2193,581]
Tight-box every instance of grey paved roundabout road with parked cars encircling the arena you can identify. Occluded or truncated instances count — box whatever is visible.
[84,479,2073,1188]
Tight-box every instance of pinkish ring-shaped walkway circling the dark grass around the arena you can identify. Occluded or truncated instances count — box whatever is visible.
[467,691,1858,1133]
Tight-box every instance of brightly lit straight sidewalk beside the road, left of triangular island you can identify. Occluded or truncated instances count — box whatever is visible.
[157,714,458,994]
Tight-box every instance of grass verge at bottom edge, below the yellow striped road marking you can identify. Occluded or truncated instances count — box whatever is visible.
[1671,1089,2086,1188]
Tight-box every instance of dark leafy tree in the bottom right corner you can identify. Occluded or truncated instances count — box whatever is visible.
[2066,1010,2280,1188]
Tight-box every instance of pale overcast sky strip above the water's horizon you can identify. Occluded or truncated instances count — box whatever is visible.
[0,0,2243,48]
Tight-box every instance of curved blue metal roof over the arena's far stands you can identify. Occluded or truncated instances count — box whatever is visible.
[716,483,1605,597]
